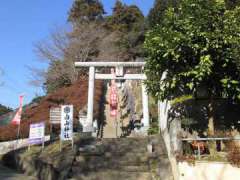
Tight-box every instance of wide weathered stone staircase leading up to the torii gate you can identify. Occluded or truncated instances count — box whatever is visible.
[70,137,173,180]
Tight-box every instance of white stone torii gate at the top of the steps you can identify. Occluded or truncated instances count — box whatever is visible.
[75,62,149,135]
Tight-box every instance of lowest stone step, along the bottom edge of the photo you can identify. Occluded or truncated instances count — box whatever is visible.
[71,170,152,180]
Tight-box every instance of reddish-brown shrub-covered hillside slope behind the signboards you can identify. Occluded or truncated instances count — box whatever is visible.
[0,80,103,141]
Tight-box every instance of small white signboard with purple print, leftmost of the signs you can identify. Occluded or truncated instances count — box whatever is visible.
[29,122,45,144]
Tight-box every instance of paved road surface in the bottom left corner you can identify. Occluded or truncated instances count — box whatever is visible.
[0,164,37,180]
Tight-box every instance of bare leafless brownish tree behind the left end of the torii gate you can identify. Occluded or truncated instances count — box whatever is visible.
[28,23,107,91]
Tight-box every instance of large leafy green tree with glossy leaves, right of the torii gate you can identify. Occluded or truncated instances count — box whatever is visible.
[145,0,240,134]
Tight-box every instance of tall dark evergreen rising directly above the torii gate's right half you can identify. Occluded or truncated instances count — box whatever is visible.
[106,1,146,61]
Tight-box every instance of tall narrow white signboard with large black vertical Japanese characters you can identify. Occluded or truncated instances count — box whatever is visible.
[61,105,73,141]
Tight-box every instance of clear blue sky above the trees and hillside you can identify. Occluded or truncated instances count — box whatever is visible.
[0,0,154,108]
